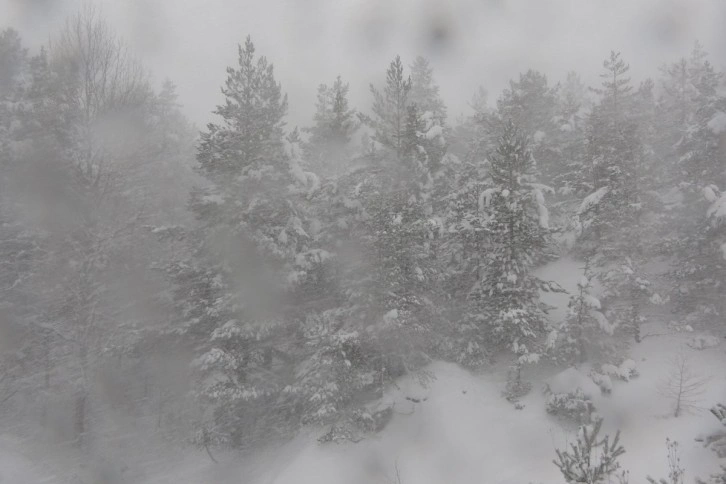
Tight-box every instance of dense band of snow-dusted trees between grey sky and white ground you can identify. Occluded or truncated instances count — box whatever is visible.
[0,5,726,482]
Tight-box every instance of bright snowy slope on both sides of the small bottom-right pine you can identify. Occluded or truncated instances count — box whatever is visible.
[249,334,726,484]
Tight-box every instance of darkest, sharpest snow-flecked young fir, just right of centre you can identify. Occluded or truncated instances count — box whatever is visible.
[468,122,549,374]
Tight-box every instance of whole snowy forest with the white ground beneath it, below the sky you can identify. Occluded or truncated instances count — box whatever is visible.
[0,3,726,484]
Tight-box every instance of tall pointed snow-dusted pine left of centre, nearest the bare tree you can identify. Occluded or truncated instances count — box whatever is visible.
[170,37,323,446]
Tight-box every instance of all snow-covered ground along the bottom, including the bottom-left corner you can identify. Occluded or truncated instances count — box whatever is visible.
[0,327,726,484]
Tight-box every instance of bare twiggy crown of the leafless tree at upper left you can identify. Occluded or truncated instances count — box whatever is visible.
[50,4,152,188]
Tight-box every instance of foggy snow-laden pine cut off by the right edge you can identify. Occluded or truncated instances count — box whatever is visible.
[662,43,726,321]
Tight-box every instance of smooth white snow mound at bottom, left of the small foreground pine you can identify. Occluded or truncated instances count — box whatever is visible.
[256,363,564,484]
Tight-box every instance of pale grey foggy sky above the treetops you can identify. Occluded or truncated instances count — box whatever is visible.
[0,0,726,126]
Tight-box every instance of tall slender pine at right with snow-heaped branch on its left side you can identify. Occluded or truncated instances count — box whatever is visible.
[577,52,650,341]
